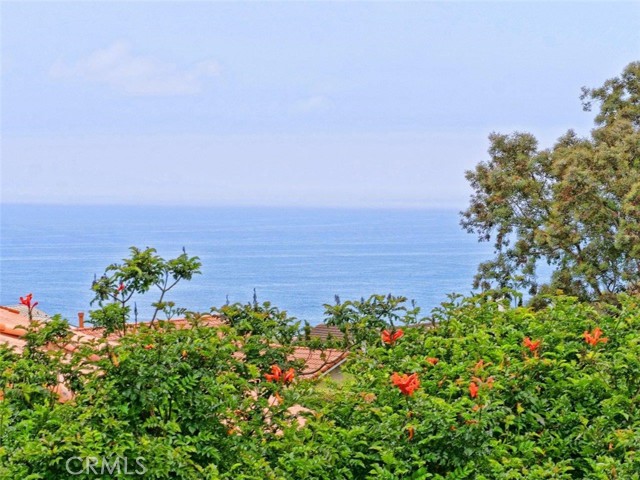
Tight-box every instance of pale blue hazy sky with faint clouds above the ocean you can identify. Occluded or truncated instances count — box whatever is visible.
[0,1,640,207]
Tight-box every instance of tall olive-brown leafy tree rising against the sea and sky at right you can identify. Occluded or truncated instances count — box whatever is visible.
[461,62,640,300]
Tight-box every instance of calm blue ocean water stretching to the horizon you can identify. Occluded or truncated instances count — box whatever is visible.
[0,205,491,324]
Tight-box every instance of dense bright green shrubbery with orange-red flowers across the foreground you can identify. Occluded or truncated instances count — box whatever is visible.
[0,290,640,480]
